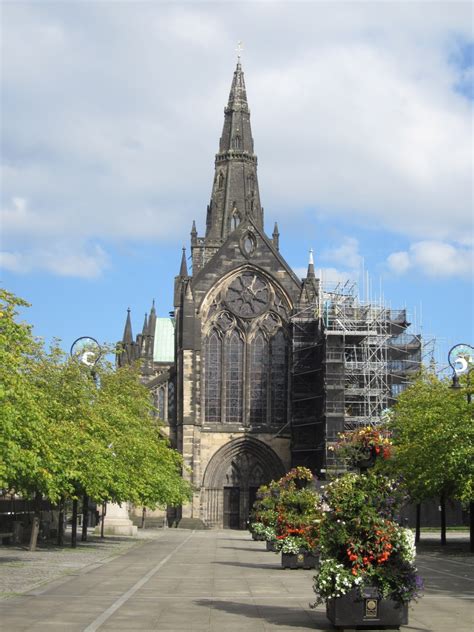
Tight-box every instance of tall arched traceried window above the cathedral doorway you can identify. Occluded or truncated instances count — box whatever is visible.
[203,268,289,425]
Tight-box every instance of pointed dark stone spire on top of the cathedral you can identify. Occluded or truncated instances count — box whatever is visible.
[206,55,263,246]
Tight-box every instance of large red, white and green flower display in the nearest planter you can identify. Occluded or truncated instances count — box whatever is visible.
[314,472,423,605]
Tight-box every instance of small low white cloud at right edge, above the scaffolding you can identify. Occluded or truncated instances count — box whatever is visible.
[387,241,474,279]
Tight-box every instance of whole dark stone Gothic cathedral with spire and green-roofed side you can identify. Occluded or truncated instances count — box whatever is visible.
[116,60,420,528]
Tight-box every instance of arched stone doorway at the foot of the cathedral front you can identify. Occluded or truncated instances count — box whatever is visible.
[202,438,285,529]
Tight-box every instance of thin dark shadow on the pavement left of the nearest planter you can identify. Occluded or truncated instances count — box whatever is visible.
[194,599,334,631]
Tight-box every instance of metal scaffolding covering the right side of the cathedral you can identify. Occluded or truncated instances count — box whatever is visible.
[292,283,421,469]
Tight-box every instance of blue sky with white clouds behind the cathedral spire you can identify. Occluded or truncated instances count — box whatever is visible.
[0,0,474,366]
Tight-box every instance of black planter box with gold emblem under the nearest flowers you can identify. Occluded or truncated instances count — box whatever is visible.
[326,586,408,628]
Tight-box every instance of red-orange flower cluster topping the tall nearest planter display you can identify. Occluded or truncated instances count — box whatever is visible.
[329,426,392,465]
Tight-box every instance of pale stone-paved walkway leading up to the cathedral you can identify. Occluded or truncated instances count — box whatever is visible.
[0,529,474,632]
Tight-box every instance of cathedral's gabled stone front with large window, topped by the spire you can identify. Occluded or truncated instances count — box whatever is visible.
[171,60,301,527]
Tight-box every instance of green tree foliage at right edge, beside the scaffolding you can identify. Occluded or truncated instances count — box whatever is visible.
[390,372,474,502]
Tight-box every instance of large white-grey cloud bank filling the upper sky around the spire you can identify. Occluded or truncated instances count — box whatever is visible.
[2,2,472,276]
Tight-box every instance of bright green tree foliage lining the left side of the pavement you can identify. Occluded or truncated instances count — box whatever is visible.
[0,290,191,508]
